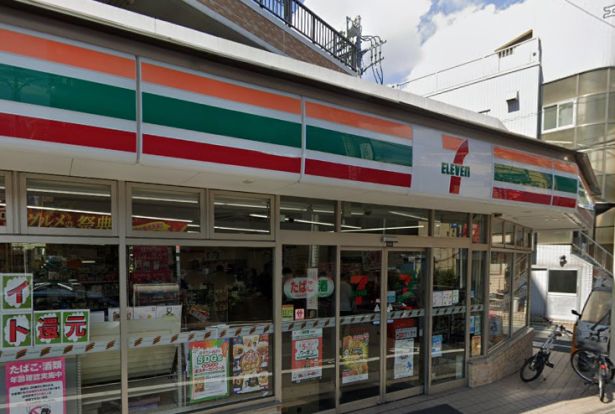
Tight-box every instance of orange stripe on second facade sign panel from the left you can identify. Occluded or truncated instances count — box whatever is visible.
[141,63,301,115]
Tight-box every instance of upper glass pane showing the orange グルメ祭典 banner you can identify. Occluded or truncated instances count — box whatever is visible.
[26,178,113,230]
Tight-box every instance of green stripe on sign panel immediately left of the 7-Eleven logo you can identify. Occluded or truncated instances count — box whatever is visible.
[307,126,412,167]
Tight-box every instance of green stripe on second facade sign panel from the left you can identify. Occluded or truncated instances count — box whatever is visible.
[143,93,301,148]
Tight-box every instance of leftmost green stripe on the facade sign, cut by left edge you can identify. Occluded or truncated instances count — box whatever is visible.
[0,64,136,120]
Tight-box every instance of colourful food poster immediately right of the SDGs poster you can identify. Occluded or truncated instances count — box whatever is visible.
[232,335,270,394]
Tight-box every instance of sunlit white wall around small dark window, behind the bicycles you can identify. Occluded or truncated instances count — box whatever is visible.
[530,244,593,321]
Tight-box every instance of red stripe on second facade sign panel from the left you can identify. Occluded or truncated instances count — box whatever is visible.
[143,135,301,174]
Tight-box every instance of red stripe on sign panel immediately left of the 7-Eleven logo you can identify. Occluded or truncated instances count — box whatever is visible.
[305,160,412,188]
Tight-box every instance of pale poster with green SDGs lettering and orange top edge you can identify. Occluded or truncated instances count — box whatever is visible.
[188,339,229,403]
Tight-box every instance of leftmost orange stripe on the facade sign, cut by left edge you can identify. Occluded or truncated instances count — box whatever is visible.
[0,29,136,79]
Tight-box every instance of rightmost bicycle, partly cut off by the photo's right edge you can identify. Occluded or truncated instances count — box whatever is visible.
[570,325,615,403]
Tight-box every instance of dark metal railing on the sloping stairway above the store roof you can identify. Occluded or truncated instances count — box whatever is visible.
[252,0,359,72]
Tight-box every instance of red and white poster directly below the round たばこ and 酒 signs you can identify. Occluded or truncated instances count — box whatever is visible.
[291,328,322,382]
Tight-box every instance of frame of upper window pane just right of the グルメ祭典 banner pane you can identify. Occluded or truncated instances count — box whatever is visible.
[126,182,209,239]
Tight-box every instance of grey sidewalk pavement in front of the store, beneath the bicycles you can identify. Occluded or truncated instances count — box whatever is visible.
[356,351,615,414]
